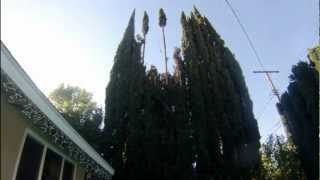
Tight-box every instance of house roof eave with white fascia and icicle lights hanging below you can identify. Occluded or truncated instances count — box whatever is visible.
[1,41,114,177]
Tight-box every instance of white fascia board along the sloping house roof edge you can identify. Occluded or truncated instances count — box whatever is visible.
[1,41,114,175]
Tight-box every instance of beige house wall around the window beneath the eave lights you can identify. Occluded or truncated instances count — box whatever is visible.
[1,93,85,180]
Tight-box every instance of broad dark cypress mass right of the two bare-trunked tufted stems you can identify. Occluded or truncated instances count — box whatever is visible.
[182,8,259,179]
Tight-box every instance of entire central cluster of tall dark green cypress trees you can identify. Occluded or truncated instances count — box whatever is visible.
[104,9,260,180]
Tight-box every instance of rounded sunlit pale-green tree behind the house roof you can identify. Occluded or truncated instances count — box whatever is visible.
[49,84,103,151]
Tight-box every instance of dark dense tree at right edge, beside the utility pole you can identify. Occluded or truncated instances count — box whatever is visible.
[278,62,319,179]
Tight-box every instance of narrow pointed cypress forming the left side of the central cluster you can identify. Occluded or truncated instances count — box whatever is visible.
[105,12,144,174]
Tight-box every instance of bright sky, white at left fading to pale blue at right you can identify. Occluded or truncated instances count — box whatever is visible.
[1,0,319,141]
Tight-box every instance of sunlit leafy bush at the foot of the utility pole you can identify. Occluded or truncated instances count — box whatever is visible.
[261,135,306,180]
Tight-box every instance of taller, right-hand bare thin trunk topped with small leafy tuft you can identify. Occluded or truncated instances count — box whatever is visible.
[159,8,168,84]
